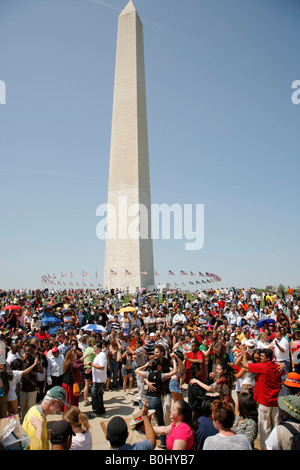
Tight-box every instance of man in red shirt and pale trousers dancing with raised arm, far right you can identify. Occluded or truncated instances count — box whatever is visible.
[242,345,285,450]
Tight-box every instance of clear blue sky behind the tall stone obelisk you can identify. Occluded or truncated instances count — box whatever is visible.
[0,0,300,289]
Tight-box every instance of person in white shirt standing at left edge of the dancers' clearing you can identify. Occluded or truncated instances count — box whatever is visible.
[89,342,107,416]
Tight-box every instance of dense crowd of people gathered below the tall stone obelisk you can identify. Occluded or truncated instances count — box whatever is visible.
[0,288,300,451]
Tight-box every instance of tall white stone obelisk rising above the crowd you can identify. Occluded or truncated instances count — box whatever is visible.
[104,0,154,292]
